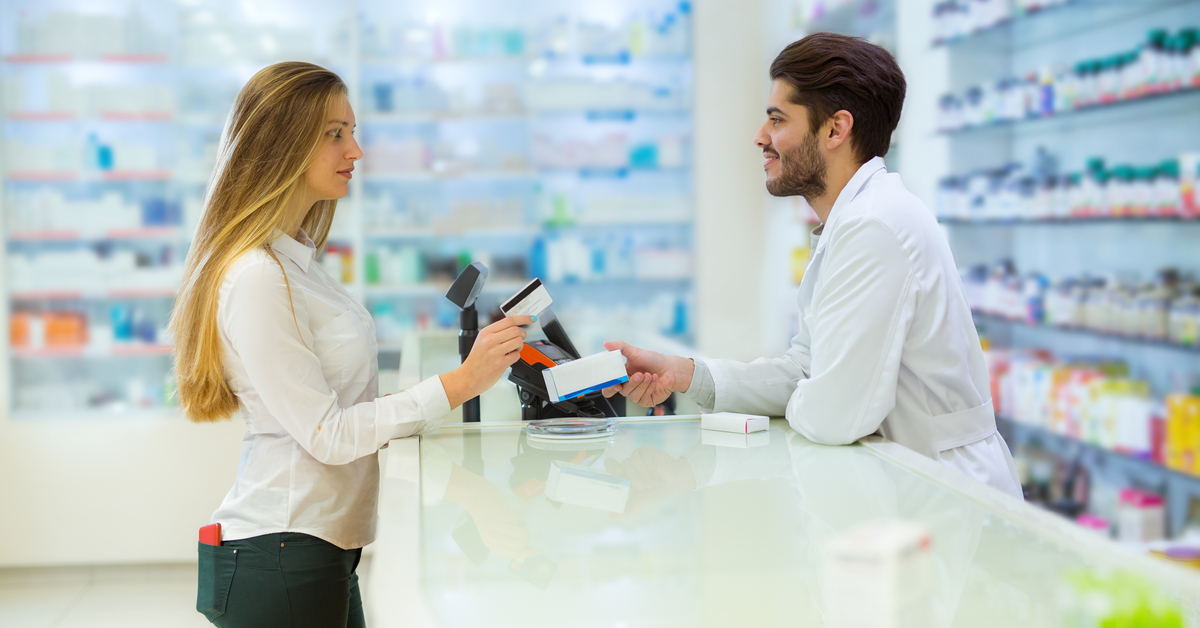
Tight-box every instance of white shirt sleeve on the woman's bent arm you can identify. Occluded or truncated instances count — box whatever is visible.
[218,261,450,465]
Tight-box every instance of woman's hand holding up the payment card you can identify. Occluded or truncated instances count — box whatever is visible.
[442,316,538,408]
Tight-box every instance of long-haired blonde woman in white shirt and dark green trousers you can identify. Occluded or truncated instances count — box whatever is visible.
[170,62,532,628]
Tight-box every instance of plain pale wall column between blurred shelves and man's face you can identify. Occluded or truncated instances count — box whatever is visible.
[695,0,767,360]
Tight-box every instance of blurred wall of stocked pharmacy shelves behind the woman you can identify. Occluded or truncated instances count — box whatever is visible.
[0,0,694,420]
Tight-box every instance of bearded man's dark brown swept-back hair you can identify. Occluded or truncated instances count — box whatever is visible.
[770,32,906,163]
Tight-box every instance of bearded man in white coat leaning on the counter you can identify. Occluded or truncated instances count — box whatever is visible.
[605,32,1021,497]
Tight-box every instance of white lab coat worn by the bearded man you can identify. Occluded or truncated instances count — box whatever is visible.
[704,157,1021,497]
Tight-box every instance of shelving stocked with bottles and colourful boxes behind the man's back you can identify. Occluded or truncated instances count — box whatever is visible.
[926,0,1200,536]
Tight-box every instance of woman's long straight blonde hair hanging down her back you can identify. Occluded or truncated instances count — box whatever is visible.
[170,61,347,423]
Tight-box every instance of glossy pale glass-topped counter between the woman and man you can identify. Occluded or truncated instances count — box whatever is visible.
[366,408,1200,628]
